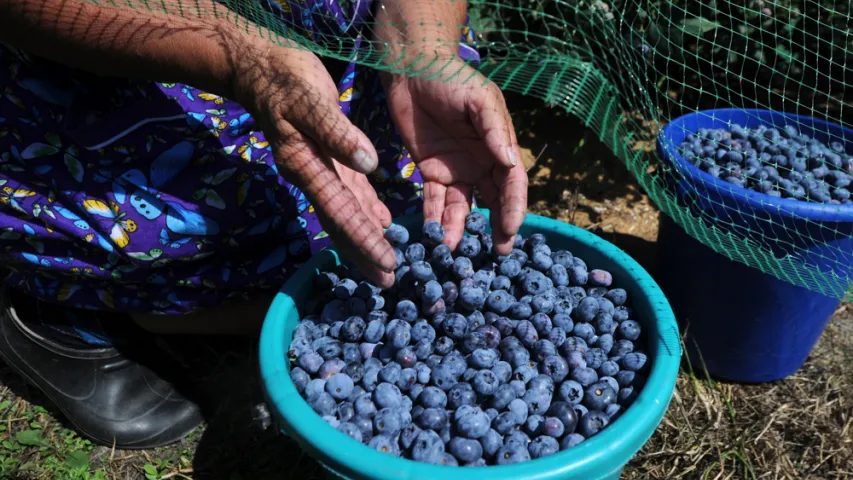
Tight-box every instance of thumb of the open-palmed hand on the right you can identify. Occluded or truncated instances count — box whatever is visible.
[467,83,521,168]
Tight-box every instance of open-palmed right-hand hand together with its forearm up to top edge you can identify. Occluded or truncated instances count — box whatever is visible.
[374,0,527,254]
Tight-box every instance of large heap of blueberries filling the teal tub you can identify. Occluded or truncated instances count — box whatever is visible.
[289,212,649,466]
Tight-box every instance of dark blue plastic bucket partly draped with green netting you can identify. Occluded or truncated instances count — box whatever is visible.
[656,109,853,383]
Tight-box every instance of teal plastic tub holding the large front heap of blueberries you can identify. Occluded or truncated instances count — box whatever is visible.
[259,210,681,480]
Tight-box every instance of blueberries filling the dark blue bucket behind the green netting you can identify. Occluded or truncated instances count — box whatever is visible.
[679,124,853,204]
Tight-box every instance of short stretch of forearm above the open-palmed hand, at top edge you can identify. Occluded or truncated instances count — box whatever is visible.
[374,0,467,61]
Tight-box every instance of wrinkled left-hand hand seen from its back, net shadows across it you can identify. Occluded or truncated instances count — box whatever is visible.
[234,40,396,287]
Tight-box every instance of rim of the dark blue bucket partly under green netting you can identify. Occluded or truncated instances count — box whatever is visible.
[656,108,853,222]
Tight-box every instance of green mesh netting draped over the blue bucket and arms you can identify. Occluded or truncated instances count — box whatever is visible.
[85,0,853,297]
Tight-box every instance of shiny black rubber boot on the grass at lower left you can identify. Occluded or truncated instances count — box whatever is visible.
[0,289,202,449]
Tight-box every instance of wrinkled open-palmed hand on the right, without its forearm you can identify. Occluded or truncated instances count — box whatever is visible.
[383,60,527,255]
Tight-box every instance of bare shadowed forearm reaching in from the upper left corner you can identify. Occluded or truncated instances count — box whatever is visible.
[0,0,253,95]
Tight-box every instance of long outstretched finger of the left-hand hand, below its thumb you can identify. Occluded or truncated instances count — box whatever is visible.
[274,121,396,287]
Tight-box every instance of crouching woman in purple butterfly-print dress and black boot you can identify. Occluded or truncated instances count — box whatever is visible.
[0,0,527,448]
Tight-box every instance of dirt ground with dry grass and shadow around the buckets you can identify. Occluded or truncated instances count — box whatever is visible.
[0,95,853,480]
